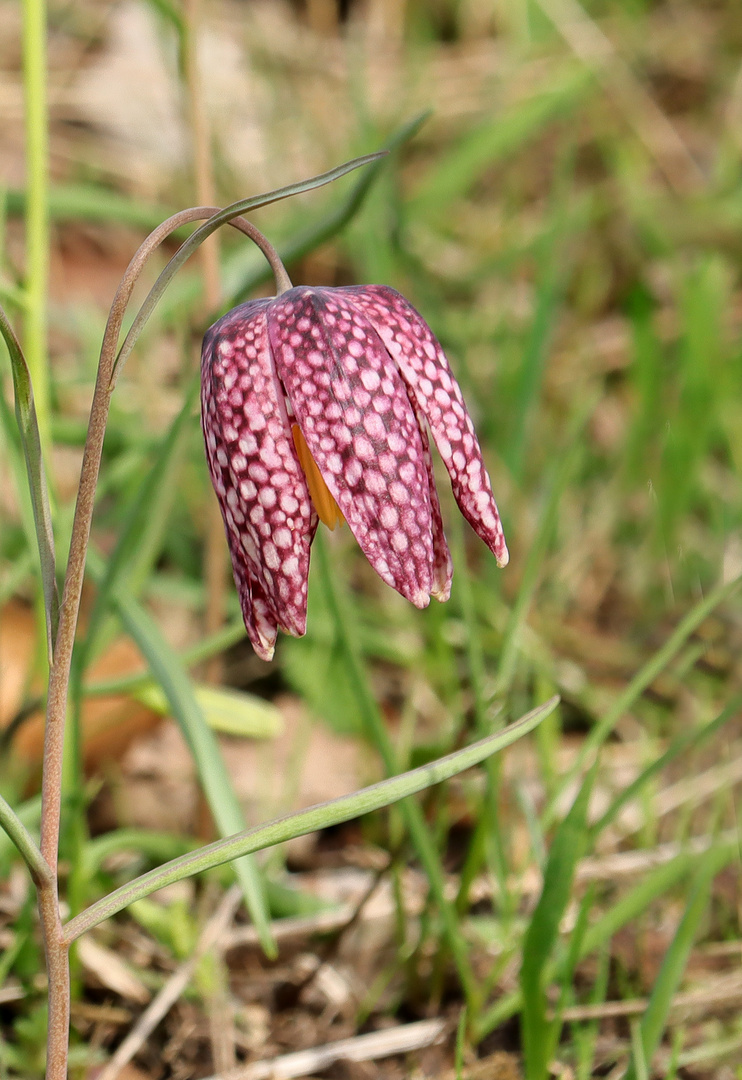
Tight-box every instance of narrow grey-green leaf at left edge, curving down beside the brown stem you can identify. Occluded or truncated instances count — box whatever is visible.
[0,307,59,662]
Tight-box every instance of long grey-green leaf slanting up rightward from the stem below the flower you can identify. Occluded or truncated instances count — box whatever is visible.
[64,699,556,942]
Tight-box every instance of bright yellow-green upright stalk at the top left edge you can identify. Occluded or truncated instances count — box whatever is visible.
[23,0,51,447]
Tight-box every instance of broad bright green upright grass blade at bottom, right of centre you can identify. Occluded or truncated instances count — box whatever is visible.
[521,764,597,1080]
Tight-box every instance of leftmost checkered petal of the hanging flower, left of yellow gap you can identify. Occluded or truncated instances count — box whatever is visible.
[202,300,318,660]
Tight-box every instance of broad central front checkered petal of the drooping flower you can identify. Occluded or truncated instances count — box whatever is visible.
[268,287,442,607]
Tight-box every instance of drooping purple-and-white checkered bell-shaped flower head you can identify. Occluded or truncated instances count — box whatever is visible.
[202,285,508,660]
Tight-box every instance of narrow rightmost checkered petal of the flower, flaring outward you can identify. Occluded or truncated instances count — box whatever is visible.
[343,285,509,566]
